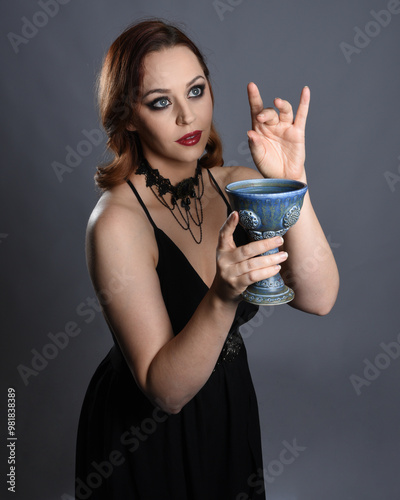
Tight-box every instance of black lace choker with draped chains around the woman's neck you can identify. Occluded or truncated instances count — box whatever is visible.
[136,158,204,244]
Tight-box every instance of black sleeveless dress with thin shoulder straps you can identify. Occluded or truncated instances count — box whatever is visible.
[75,173,265,500]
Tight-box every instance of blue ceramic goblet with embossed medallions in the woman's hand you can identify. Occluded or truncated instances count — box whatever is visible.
[225,179,307,305]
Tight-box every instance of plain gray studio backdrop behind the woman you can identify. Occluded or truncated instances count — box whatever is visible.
[0,0,400,500]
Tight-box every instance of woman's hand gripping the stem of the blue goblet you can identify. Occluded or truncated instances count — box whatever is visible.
[211,211,288,302]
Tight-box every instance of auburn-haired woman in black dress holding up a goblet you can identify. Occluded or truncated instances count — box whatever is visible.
[76,21,338,500]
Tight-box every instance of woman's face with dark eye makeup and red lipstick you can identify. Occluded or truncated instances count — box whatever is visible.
[132,45,213,168]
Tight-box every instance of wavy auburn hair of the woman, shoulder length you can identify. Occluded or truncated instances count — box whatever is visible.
[95,19,223,190]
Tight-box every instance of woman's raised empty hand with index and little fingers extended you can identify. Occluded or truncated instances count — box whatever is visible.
[247,83,310,182]
